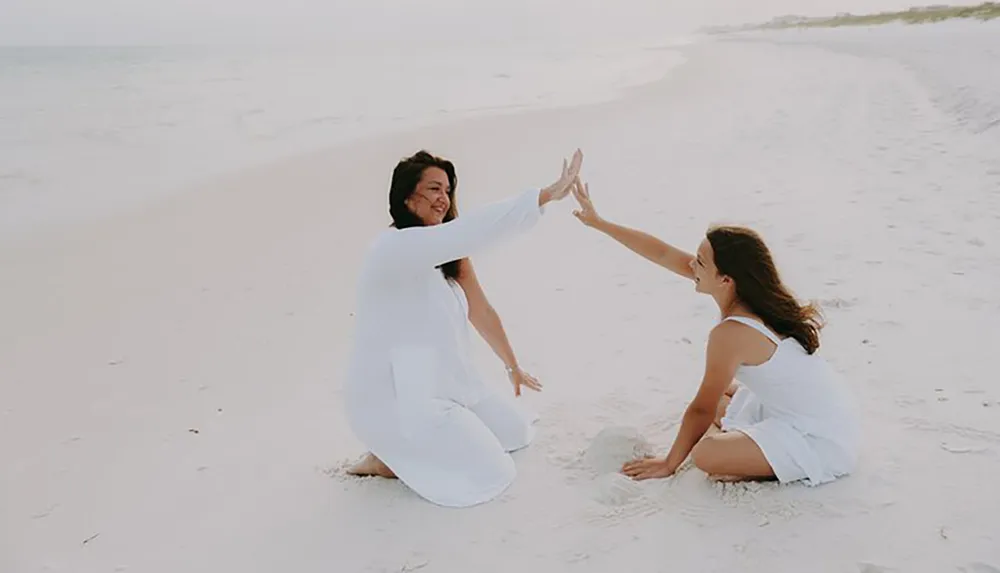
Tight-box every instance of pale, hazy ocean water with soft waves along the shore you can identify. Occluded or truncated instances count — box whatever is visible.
[0,37,694,238]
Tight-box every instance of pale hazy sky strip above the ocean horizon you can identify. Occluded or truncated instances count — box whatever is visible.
[0,0,914,45]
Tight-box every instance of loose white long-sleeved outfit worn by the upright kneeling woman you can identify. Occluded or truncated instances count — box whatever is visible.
[345,187,543,507]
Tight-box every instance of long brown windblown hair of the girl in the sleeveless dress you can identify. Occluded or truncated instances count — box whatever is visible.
[707,226,823,354]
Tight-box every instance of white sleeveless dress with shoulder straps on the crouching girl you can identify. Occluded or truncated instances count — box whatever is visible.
[722,316,860,485]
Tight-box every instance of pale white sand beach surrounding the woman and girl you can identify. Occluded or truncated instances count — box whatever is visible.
[0,20,1000,573]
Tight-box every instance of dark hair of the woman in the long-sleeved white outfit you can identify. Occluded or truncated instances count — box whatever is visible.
[389,150,462,280]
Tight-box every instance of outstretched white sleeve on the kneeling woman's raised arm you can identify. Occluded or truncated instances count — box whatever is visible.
[372,190,544,276]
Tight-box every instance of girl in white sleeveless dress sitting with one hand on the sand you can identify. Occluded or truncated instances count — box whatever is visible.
[573,177,859,485]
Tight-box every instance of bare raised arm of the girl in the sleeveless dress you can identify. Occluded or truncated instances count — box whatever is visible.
[573,177,694,280]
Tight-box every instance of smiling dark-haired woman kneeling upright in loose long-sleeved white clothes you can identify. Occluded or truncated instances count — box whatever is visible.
[346,146,583,507]
